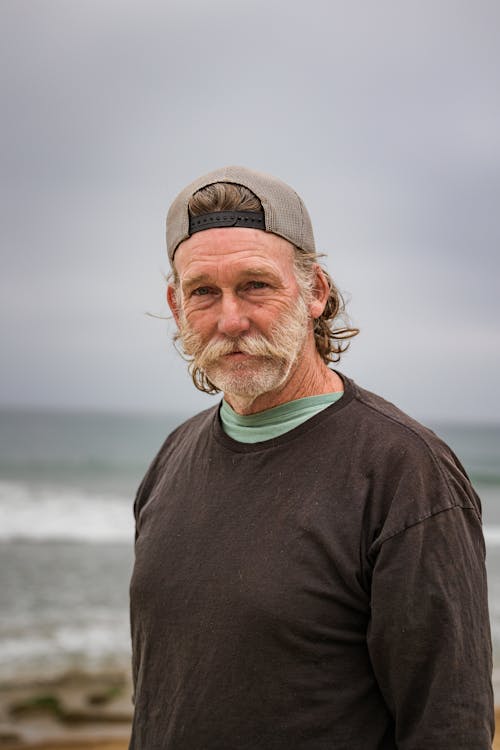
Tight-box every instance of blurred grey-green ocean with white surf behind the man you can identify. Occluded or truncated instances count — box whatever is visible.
[0,410,500,683]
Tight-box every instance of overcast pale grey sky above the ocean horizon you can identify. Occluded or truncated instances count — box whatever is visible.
[0,0,500,422]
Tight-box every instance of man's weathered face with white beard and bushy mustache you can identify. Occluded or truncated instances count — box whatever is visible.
[169,228,312,398]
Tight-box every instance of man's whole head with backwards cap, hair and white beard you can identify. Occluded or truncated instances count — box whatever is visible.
[167,167,357,396]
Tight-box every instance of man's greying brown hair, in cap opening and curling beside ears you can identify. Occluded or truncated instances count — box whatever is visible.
[180,182,359,364]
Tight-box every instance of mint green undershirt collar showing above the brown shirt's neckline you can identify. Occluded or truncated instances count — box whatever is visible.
[220,391,343,443]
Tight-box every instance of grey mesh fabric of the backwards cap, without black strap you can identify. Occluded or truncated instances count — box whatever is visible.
[167,167,315,263]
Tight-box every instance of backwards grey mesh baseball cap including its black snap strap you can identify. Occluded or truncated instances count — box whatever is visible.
[167,167,315,263]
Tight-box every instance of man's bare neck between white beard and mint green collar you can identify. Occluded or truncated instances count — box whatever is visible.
[224,355,344,415]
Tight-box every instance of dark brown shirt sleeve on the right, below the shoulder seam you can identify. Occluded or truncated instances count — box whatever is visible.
[368,507,493,750]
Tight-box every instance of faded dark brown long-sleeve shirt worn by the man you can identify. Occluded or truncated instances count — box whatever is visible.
[130,378,493,750]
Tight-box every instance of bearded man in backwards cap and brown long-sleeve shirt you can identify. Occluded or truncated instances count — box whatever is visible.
[130,167,492,750]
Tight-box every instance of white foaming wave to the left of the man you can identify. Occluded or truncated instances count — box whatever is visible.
[0,481,134,544]
